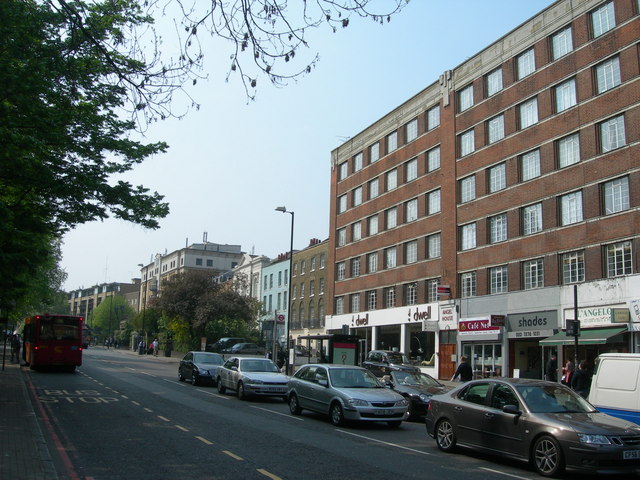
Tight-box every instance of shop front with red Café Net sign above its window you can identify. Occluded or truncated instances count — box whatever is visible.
[458,315,504,378]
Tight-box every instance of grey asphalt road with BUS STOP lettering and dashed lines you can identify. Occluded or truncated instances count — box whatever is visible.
[22,348,577,480]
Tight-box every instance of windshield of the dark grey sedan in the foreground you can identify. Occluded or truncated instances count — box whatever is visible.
[516,385,596,413]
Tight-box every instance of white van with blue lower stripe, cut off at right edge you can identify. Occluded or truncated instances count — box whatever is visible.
[588,353,640,425]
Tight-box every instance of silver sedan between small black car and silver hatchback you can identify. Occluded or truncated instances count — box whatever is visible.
[216,357,289,400]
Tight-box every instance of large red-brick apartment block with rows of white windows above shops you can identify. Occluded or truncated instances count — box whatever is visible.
[326,0,640,378]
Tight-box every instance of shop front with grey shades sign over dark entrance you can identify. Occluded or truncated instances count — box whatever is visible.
[505,310,559,378]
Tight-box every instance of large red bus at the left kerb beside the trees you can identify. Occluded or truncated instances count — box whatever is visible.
[23,313,83,371]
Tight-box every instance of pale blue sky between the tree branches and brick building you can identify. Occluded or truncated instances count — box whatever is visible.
[62,0,554,290]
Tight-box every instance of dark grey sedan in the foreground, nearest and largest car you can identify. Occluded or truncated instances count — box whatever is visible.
[426,378,640,478]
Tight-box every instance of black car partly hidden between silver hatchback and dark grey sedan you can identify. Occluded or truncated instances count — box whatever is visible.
[382,368,451,418]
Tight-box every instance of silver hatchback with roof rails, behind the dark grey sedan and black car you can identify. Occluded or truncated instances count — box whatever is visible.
[287,363,408,427]
